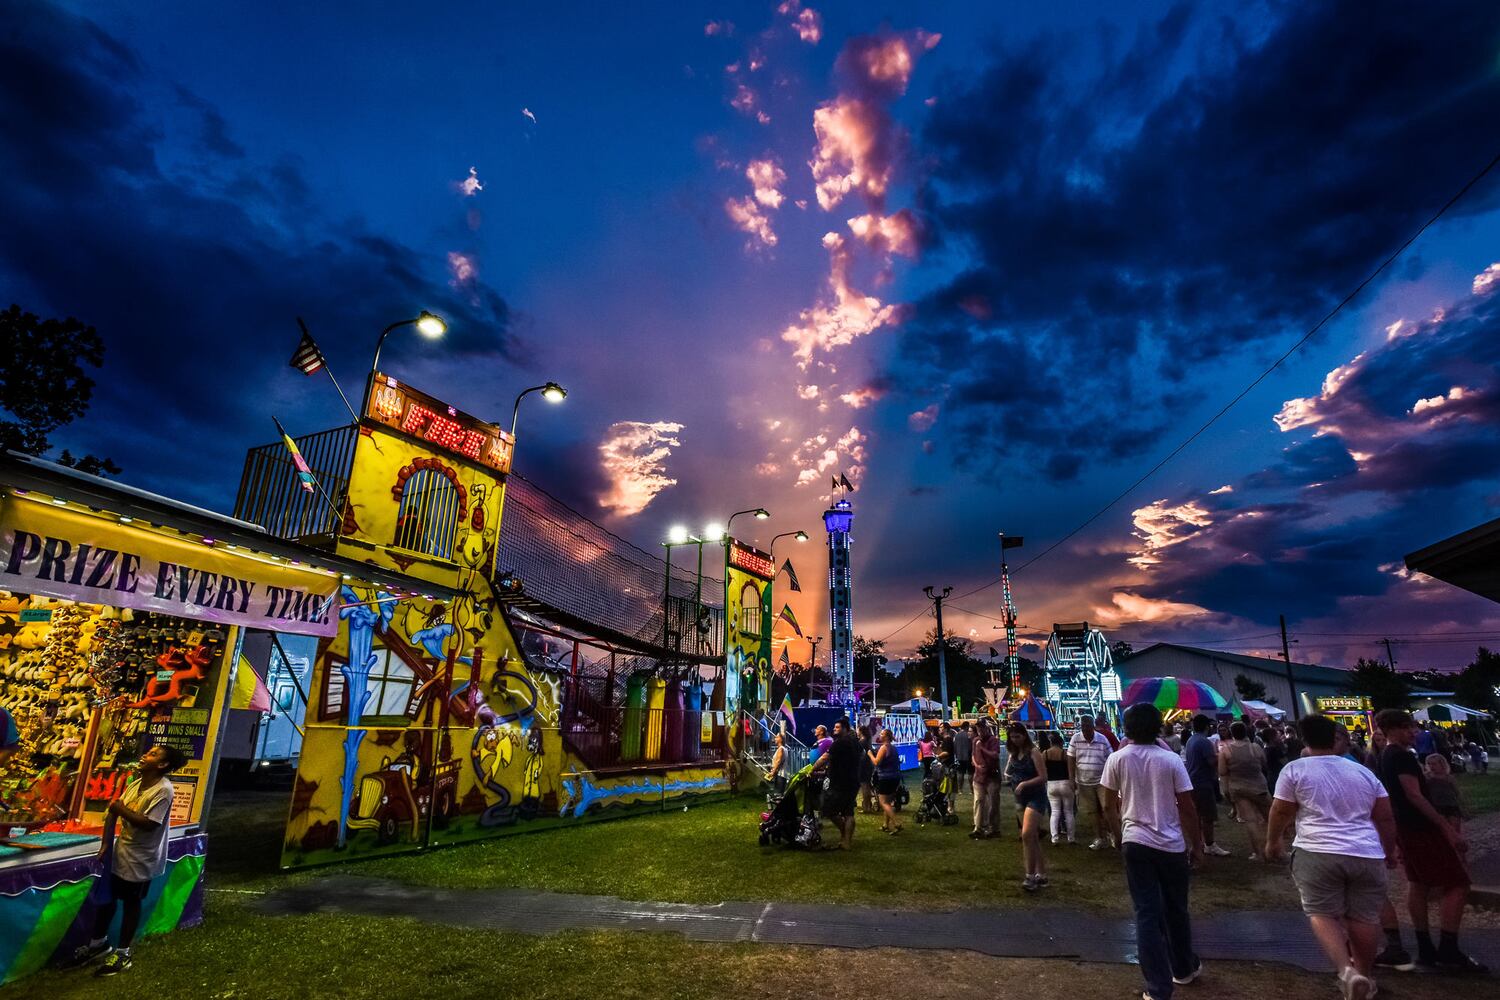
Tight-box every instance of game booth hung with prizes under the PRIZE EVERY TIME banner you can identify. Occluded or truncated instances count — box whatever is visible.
[0,454,447,982]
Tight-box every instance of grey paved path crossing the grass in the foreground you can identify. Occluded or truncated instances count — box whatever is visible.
[255,876,1500,972]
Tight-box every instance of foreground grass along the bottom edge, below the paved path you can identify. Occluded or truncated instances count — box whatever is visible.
[0,901,1476,1000]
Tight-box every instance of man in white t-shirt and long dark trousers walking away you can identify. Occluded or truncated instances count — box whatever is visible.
[1100,703,1203,1000]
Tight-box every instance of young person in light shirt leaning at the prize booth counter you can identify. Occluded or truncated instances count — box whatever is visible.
[75,745,188,976]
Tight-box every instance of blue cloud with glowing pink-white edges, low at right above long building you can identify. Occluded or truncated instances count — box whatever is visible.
[1106,274,1500,657]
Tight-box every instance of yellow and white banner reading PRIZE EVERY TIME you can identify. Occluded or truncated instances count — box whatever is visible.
[0,498,339,636]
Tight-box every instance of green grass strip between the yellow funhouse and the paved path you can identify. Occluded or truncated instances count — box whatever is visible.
[209,795,1296,915]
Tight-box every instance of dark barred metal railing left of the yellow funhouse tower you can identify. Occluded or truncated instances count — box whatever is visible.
[234,424,357,540]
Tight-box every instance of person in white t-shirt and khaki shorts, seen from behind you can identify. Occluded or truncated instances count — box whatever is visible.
[1266,715,1397,1000]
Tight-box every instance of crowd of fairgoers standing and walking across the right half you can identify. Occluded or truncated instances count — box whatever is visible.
[768,705,1488,1000]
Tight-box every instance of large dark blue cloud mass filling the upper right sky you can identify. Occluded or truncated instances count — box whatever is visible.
[894,0,1500,480]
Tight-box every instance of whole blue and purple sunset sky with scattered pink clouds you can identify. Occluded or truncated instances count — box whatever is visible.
[0,0,1500,667]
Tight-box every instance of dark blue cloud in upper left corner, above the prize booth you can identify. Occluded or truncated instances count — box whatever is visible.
[0,3,528,507]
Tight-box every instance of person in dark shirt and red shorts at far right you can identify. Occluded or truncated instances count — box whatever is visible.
[1376,709,1488,973]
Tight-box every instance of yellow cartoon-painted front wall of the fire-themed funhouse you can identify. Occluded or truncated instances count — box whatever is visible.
[282,407,732,867]
